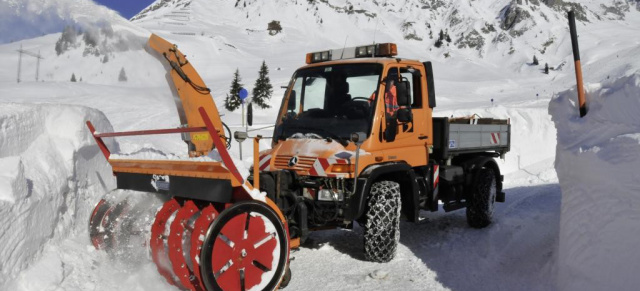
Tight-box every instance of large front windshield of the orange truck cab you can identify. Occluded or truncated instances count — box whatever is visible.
[276,64,382,144]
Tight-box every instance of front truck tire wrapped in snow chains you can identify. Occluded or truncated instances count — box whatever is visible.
[364,181,401,263]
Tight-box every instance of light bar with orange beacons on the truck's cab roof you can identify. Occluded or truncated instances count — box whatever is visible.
[306,43,398,64]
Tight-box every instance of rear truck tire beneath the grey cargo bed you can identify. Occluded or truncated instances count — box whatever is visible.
[467,168,498,228]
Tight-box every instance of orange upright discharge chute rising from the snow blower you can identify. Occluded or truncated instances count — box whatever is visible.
[149,34,224,156]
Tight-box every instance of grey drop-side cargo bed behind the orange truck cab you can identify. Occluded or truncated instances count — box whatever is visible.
[431,117,511,161]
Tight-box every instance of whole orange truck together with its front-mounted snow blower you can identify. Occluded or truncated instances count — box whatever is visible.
[87,35,511,290]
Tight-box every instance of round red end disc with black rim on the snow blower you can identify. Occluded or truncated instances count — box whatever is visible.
[200,201,289,291]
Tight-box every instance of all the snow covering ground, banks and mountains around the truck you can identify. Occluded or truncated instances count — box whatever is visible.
[0,0,640,290]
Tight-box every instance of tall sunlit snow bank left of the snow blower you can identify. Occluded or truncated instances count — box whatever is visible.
[0,103,117,289]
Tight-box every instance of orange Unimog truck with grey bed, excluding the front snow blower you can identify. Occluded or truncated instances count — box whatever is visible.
[254,43,511,262]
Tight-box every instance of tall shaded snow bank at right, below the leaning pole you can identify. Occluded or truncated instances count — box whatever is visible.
[549,72,640,290]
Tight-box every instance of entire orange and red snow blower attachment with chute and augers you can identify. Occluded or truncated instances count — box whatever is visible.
[87,35,296,290]
